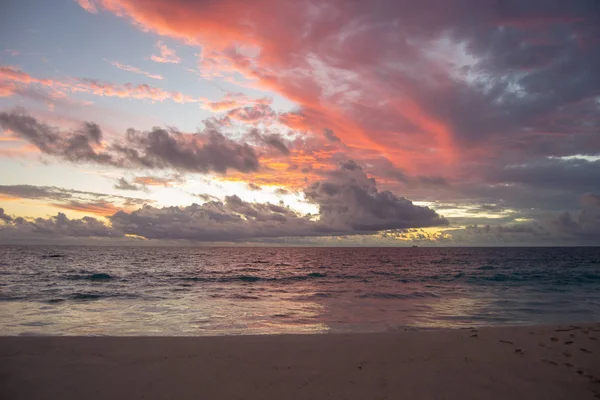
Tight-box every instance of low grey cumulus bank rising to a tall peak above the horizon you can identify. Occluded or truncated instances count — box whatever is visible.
[110,161,448,241]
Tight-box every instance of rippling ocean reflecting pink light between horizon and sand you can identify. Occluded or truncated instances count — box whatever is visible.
[0,246,600,336]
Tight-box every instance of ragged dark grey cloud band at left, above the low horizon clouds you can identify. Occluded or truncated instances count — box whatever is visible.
[0,111,262,173]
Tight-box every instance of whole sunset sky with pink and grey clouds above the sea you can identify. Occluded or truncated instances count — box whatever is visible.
[0,0,600,246]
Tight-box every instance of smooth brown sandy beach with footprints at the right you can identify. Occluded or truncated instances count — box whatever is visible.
[0,323,600,400]
